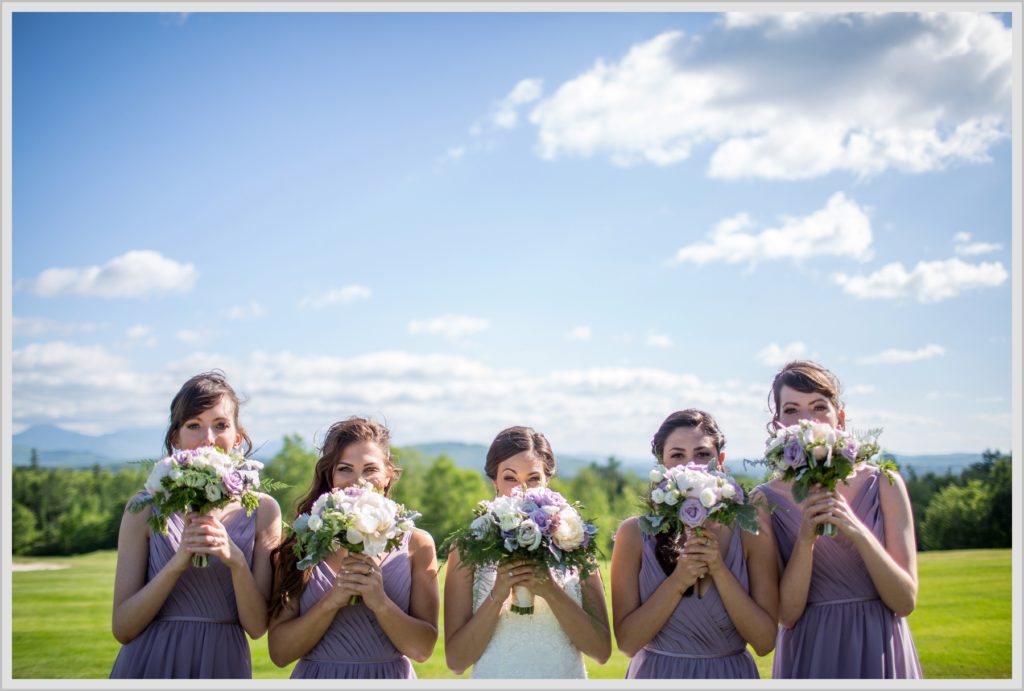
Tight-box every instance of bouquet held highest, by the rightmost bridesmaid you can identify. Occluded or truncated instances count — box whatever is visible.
[765,420,898,536]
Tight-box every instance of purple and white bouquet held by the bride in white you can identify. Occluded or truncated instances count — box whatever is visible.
[447,487,597,614]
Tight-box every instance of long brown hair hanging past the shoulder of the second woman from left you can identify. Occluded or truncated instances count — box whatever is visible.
[270,417,401,618]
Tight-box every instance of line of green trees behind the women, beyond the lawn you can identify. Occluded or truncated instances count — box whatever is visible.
[11,444,1013,557]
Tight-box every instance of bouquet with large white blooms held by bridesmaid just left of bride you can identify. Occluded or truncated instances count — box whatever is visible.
[291,479,420,605]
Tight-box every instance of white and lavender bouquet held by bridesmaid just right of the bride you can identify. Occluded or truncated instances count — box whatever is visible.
[639,463,759,536]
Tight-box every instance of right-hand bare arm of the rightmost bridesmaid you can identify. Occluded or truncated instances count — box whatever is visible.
[831,474,918,616]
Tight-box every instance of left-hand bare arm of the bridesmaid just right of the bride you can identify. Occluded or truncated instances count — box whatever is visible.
[611,517,708,657]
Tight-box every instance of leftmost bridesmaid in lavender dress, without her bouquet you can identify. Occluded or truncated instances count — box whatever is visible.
[111,372,281,679]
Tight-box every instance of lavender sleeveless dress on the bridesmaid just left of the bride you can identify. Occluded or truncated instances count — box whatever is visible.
[292,532,416,679]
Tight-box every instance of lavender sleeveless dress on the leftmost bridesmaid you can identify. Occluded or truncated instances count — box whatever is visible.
[111,509,257,679]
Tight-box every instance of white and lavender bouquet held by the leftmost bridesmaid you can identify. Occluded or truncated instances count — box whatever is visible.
[128,446,283,567]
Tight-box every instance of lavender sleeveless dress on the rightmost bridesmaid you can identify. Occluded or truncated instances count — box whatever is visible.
[758,470,923,679]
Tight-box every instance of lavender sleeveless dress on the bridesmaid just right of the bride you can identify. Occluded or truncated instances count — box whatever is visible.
[626,528,759,679]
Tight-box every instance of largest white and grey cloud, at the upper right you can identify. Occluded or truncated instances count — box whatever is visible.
[529,12,1012,179]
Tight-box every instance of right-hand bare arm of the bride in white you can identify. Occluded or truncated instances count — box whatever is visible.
[522,572,611,664]
